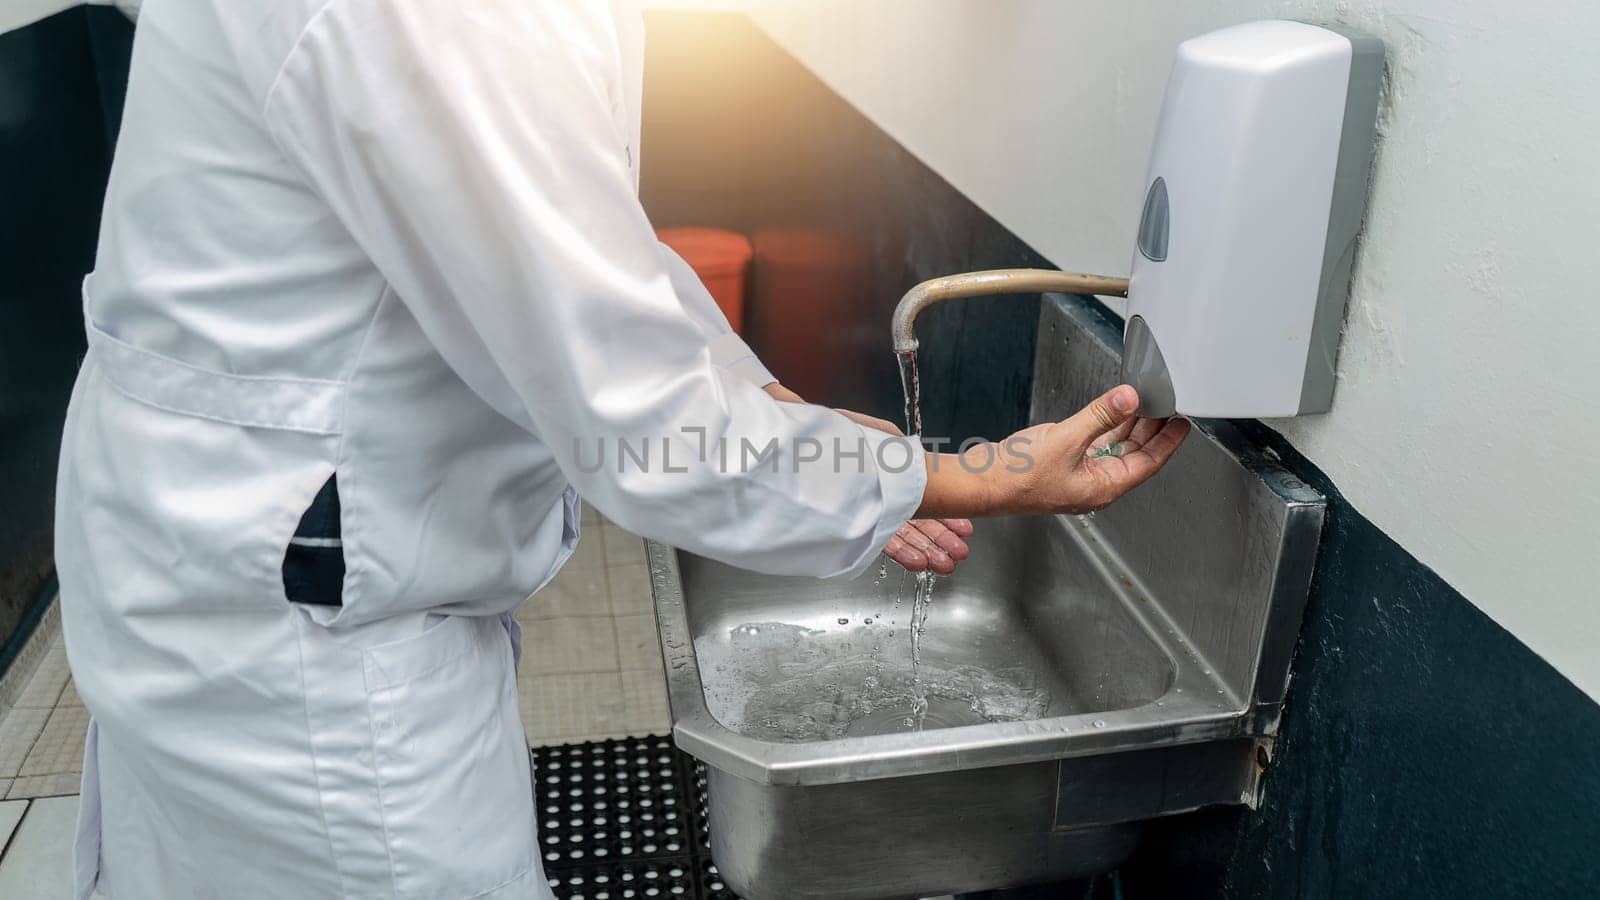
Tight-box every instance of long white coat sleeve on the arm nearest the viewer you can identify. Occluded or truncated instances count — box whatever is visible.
[264,0,926,575]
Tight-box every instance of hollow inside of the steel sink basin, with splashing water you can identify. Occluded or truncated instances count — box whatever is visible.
[677,517,1190,743]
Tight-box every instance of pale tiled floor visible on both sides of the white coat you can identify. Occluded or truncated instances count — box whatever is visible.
[0,508,672,900]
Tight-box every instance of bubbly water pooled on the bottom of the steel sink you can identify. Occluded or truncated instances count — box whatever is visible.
[694,621,1051,743]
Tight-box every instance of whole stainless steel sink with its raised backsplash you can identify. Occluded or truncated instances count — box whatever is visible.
[650,298,1323,900]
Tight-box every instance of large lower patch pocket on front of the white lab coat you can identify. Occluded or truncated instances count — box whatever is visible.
[363,617,536,900]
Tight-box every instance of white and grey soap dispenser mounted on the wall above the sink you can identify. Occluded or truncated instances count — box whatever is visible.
[1122,21,1384,418]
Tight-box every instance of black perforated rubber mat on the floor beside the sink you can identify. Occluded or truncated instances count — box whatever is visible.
[530,737,739,900]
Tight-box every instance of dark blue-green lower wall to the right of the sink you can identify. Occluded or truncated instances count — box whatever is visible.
[1123,428,1600,898]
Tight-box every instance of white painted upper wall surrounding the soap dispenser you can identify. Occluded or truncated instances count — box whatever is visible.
[749,0,1600,698]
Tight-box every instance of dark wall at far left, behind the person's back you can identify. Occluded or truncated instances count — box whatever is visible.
[0,8,130,666]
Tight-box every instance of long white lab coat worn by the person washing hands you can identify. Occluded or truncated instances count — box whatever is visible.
[56,0,925,900]
